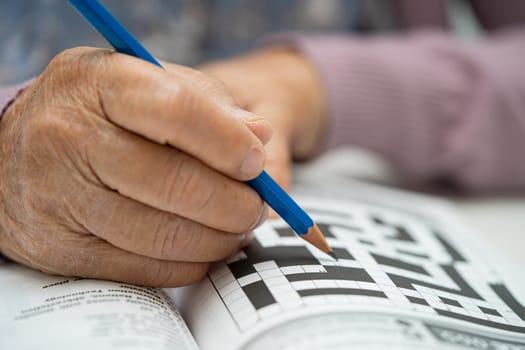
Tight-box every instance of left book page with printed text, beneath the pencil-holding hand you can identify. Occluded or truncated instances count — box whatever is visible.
[0,258,197,350]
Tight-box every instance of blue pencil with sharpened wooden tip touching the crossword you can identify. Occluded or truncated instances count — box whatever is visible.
[69,0,333,256]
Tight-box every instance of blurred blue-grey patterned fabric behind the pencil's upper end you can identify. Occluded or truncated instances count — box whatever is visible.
[0,0,395,85]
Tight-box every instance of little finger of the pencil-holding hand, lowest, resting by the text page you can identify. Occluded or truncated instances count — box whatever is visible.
[41,233,209,287]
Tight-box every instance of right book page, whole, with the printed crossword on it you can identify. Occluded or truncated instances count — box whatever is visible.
[171,184,525,350]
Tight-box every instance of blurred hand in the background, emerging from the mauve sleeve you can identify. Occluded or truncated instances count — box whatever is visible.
[200,48,326,189]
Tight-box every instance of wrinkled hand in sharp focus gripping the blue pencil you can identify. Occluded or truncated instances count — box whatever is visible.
[0,48,271,286]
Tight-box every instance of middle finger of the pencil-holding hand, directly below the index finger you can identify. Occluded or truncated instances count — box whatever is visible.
[87,121,264,233]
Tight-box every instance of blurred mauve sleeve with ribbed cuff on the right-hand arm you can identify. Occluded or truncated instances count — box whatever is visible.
[284,28,525,190]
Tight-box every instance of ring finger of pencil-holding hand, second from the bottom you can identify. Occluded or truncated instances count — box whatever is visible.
[72,185,250,262]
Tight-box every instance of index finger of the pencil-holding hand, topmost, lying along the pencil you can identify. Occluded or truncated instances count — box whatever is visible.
[94,54,270,180]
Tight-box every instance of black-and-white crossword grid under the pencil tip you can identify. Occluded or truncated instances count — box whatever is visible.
[209,204,525,333]
